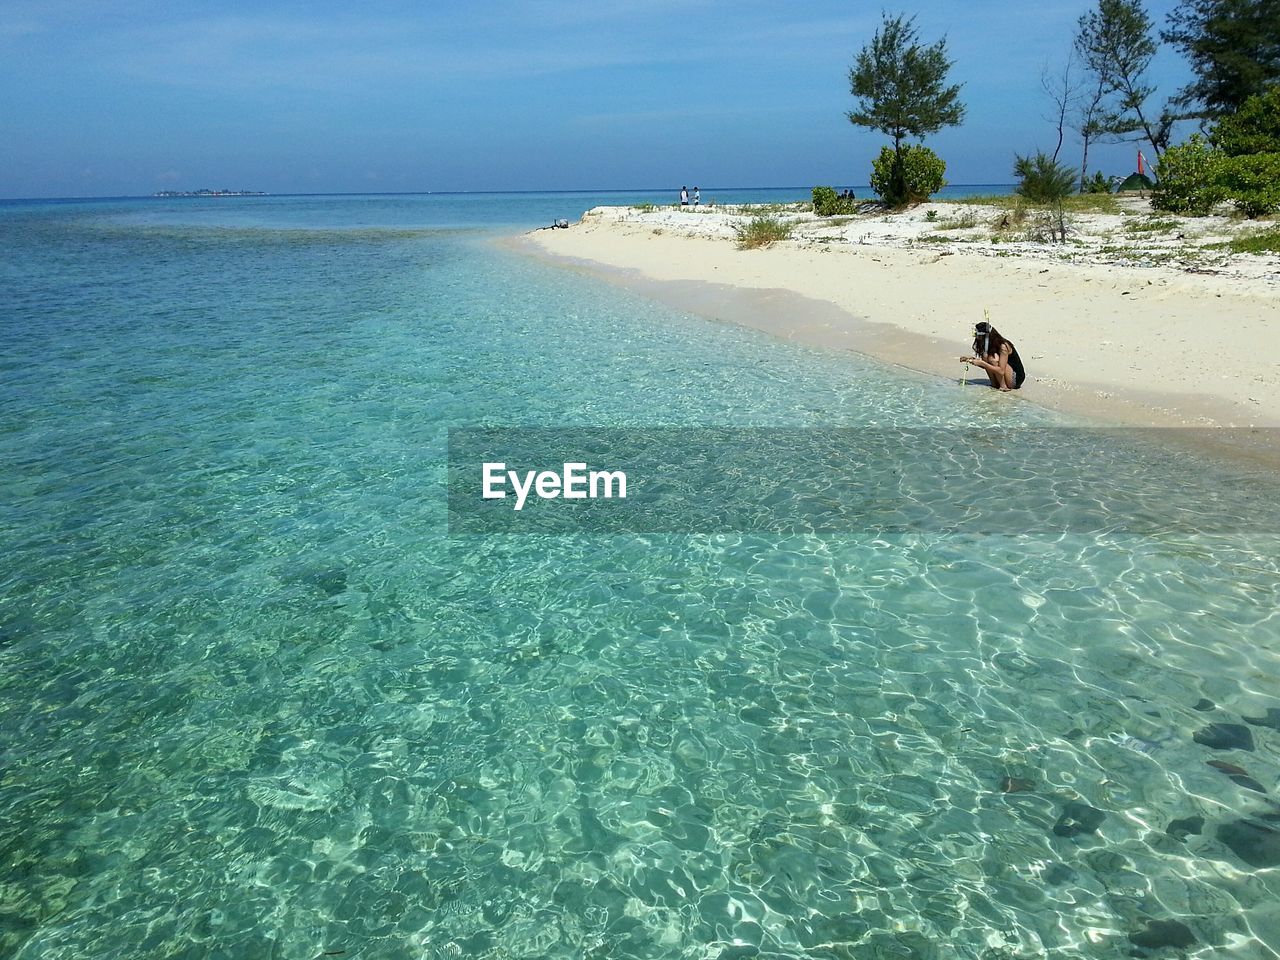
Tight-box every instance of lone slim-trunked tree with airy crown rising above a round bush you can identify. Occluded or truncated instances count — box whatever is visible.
[846,15,964,204]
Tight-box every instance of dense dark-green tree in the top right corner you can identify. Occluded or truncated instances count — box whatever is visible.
[1160,0,1280,118]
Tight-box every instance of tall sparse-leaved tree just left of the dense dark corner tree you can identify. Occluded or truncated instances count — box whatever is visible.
[1075,0,1175,157]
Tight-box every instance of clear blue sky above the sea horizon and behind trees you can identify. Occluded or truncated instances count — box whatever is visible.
[0,0,1189,197]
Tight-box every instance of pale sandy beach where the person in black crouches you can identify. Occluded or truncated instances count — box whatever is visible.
[517,198,1280,428]
